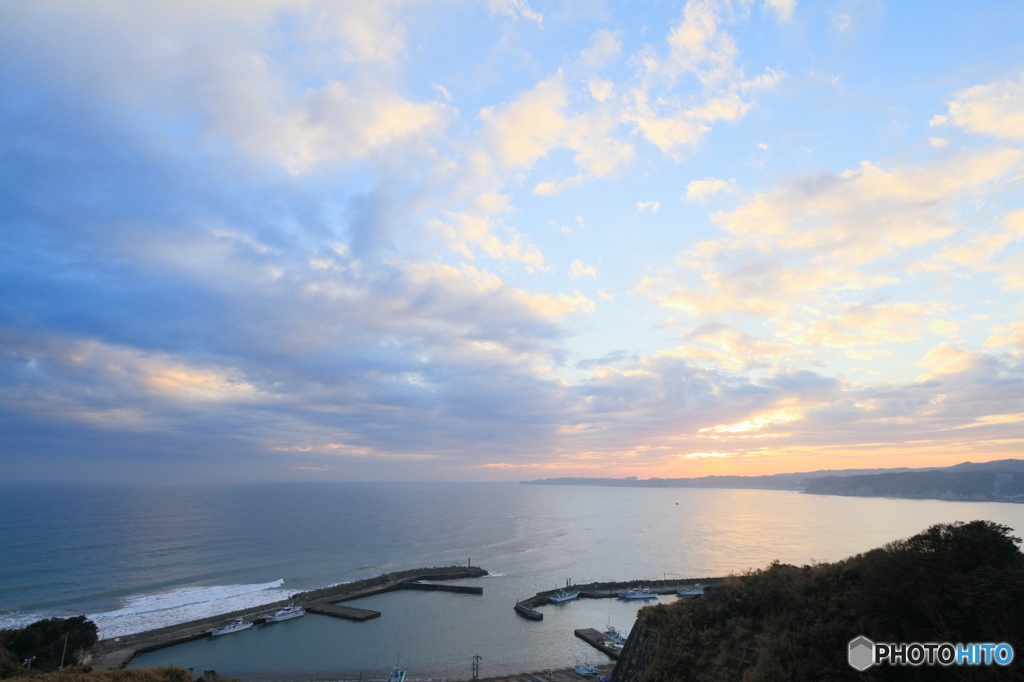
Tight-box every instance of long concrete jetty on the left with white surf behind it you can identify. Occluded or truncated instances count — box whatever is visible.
[89,566,487,670]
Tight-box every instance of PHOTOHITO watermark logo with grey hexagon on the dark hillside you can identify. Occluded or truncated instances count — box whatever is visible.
[847,636,1014,672]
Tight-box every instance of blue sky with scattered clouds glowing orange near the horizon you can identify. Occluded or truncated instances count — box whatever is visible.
[0,0,1024,481]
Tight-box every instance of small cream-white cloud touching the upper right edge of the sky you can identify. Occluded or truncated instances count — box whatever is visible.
[933,76,1024,139]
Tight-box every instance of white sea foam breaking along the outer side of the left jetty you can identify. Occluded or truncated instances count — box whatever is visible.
[89,580,292,639]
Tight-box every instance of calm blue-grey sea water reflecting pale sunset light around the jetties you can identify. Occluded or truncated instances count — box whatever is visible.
[0,483,1024,679]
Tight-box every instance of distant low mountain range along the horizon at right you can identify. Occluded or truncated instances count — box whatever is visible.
[519,460,1024,502]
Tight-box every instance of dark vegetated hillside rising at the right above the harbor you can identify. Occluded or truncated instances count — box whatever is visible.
[640,521,1024,682]
